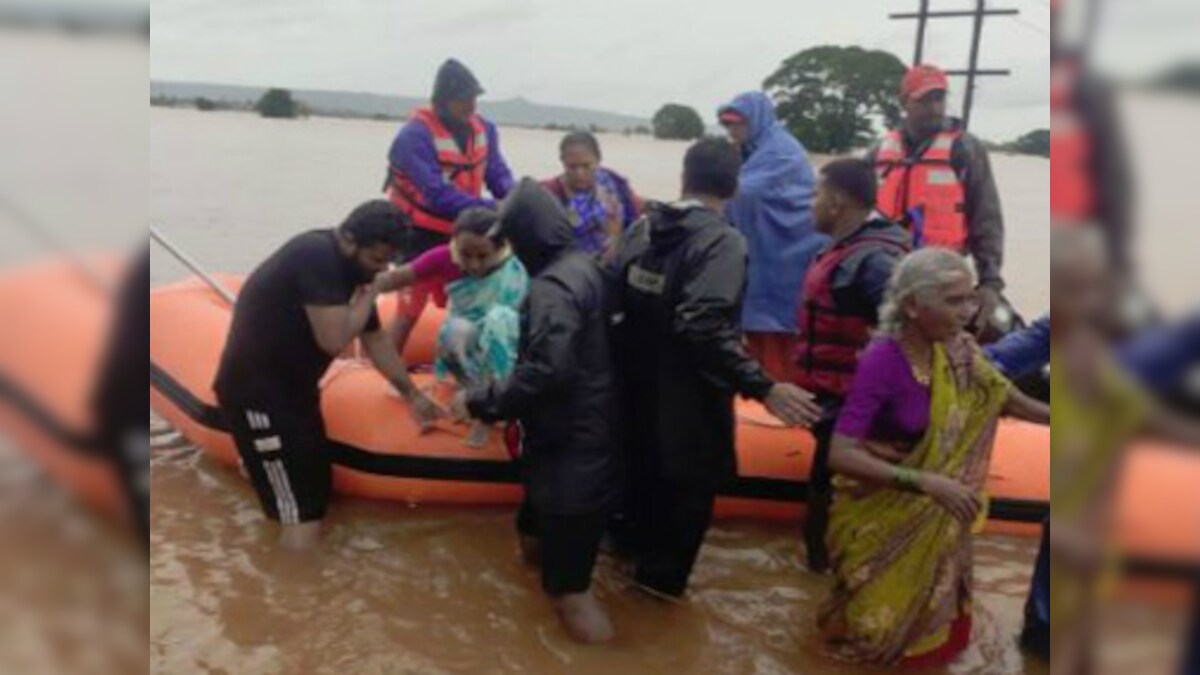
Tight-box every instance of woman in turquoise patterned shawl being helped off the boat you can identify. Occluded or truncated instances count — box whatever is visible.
[374,208,529,448]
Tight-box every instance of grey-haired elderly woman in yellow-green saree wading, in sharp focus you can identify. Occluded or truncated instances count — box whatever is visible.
[818,249,1050,667]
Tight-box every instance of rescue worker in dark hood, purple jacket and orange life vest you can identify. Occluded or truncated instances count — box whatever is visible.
[384,59,514,351]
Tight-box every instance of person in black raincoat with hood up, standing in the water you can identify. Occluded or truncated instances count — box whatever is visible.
[456,179,624,643]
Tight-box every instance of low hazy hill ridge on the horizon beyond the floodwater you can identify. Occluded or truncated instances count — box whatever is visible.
[150,80,650,131]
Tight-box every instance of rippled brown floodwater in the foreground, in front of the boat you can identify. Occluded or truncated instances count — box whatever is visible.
[150,410,1042,675]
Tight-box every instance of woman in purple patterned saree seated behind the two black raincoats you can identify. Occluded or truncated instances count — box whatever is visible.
[541,131,642,257]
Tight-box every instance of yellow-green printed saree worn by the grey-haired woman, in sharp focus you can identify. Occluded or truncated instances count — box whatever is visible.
[818,336,1010,665]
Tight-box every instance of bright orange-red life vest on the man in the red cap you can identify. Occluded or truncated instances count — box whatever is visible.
[875,131,967,253]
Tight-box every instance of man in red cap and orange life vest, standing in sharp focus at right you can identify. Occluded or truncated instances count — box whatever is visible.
[866,65,1013,339]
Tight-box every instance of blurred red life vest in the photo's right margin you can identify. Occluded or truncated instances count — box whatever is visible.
[1050,60,1096,226]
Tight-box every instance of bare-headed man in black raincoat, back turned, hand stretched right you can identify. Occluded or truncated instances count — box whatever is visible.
[613,141,821,597]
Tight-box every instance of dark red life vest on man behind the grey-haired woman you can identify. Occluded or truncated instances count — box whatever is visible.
[796,237,908,399]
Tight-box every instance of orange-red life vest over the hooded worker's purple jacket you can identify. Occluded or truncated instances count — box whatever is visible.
[388,108,488,234]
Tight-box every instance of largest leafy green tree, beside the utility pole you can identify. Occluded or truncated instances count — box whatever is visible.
[763,46,906,153]
